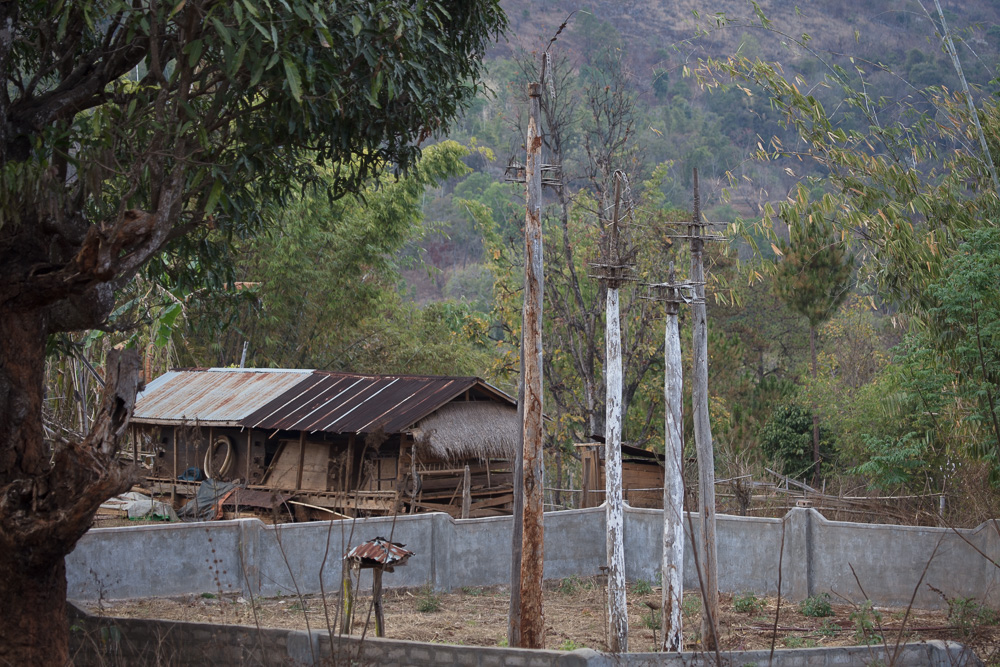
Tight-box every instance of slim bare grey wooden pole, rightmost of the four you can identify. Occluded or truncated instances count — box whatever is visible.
[689,169,719,650]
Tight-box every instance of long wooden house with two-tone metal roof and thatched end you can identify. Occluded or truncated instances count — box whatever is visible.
[132,368,520,518]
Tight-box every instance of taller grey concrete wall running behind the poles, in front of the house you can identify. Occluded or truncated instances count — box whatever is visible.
[67,508,1000,608]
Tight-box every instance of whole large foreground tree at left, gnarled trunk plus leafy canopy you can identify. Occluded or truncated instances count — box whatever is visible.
[0,0,506,664]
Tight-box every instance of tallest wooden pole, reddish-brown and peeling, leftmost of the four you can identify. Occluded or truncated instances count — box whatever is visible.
[520,83,545,648]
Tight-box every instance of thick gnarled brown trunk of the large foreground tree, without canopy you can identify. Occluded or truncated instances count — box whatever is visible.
[0,309,139,665]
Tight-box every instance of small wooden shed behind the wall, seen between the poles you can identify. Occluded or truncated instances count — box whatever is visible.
[576,442,663,509]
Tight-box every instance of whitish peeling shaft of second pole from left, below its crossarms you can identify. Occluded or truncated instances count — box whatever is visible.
[604,287,628,653]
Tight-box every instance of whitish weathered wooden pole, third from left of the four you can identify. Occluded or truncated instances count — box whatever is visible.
[660,262,684,651]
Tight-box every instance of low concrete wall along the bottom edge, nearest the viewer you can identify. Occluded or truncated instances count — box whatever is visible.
[69,604,983,667]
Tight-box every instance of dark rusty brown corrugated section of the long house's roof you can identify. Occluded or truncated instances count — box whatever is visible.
[243,371,514,433]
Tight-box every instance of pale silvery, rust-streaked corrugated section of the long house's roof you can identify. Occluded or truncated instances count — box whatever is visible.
[132,368,312,426]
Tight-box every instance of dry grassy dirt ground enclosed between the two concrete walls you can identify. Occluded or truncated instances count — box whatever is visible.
[91,577,1000,665]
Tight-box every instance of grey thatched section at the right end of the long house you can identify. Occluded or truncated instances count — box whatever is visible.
[413,401,520,461]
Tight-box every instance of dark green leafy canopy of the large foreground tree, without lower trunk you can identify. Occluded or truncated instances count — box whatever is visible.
[0,0,504,329]
